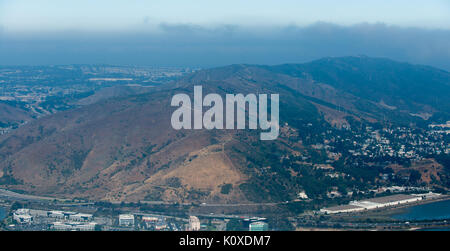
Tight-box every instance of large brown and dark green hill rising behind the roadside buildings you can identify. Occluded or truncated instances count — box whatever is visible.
[0,57,450,202]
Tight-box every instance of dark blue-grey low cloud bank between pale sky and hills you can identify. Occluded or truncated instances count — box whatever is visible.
[0,23,450,70]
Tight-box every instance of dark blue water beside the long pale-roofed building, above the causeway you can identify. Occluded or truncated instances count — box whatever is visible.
[392,200,450,221]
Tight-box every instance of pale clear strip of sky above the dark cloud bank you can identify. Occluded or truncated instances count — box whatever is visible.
[0,0,450,31]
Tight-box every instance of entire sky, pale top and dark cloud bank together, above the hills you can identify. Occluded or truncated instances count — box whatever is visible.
[0,0,450,70]
